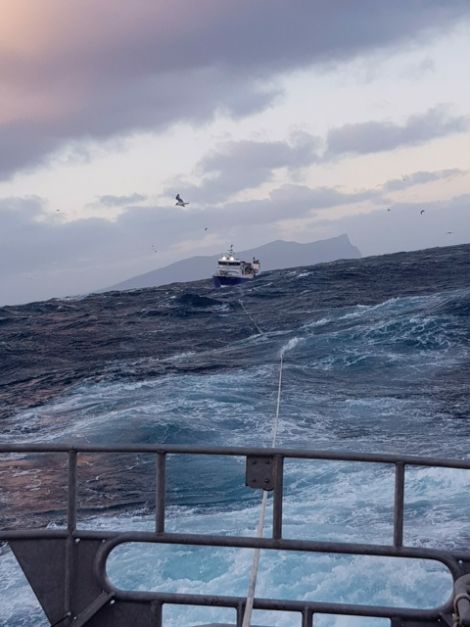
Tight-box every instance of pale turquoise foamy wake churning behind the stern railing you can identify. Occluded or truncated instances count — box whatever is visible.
[0,288,470,627]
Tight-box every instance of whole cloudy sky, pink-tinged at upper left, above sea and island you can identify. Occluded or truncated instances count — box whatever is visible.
[0,0,470,304]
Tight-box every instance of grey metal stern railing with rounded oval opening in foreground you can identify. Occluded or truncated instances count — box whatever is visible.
[0,444,470,627]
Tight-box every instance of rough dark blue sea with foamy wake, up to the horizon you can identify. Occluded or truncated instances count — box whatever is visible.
[0,245,470,627]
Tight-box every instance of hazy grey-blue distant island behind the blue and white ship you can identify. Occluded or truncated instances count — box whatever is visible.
[103,235,361,291]
